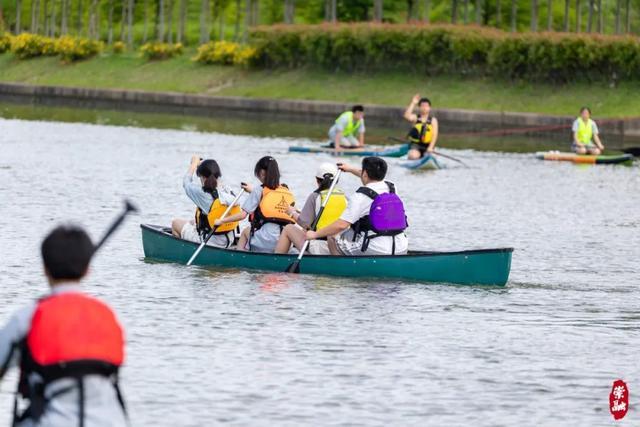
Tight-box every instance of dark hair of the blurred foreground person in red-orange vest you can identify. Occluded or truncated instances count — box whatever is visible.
[40,226,94,280]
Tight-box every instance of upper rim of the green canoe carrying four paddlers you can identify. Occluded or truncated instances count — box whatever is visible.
[140,224,514,259]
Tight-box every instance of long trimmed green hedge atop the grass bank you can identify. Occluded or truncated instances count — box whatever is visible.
[251,24,640,82]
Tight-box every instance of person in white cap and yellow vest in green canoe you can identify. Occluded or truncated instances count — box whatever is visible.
[275,163,347,255]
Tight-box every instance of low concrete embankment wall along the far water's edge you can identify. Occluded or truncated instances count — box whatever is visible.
[0,83,640,140]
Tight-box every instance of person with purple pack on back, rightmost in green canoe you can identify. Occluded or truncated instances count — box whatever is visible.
[307,157,409,256]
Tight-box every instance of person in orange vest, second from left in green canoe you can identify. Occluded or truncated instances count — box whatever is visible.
[214,156,295,252]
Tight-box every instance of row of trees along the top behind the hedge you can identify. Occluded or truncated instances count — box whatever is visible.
[0,0,640,47]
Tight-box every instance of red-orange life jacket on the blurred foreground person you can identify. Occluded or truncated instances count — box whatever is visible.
[14,292,124,425]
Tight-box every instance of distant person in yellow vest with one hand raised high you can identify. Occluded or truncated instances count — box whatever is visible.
[404,94,438,160]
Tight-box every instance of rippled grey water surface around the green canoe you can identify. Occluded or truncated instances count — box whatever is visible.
[0,119,640,426]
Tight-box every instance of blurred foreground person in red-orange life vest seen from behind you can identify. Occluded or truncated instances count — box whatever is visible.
[0,226,127,427]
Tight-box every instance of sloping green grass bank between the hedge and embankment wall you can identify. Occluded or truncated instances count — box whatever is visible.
[0,52,640,118]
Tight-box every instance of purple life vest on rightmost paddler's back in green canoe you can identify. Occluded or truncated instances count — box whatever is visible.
[356,181,408,240]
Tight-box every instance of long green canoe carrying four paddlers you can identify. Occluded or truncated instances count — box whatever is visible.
[141,224,513,286]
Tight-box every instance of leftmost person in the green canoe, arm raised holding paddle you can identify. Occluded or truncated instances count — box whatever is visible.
[171,156,240,248]
